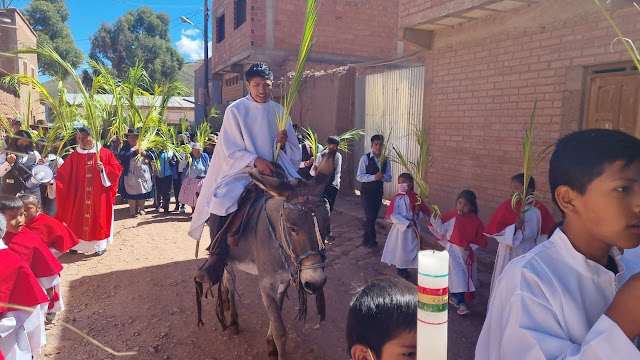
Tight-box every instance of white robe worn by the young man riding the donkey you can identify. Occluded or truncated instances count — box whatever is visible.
[189,95,302,240]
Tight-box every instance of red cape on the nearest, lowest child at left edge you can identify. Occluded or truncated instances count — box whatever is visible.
[0,248,49,314]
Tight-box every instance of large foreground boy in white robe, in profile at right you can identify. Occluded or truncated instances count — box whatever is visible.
[475,129,640,360]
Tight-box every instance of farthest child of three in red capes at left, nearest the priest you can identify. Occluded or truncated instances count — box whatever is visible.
[18,194,80,257]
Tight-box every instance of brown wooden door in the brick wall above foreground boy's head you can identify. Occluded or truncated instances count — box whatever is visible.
[587,75,640,137]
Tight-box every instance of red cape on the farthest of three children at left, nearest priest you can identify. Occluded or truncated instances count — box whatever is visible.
[26,213,80,253]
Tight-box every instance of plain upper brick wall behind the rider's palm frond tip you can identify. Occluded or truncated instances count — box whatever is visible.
[275,0,398,58]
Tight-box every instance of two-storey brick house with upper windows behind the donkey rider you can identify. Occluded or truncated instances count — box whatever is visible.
[194,0,405,122]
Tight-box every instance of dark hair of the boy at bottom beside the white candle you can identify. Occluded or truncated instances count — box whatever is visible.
[347,277,418,359]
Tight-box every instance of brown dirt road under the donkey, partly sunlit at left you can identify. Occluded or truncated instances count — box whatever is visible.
[36,202,486,360]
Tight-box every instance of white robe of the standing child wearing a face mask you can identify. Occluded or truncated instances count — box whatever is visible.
[382,196,420,269]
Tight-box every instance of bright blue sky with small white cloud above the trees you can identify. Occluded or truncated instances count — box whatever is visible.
[20,0,209,69]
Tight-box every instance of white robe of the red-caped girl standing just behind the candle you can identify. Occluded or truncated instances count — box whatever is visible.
[429,216,479,294]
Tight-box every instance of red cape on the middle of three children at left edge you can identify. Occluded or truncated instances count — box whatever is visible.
[2,226,62,279]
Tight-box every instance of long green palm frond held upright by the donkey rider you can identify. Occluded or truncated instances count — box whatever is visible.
[274,0,318,162]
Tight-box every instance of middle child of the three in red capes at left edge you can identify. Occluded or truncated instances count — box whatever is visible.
[0,195,64,321]
